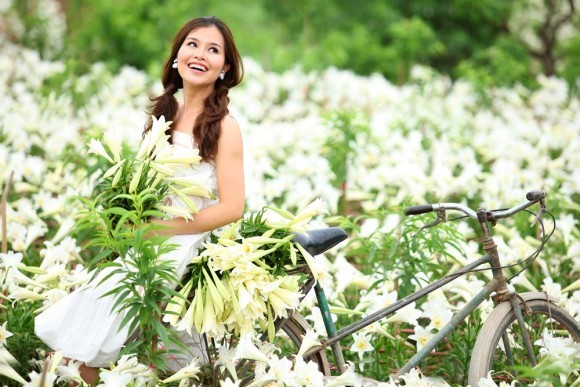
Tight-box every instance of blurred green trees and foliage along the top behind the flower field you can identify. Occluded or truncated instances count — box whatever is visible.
[5,0,580,90]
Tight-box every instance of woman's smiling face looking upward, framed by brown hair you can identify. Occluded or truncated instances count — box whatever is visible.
[177,26,229,86]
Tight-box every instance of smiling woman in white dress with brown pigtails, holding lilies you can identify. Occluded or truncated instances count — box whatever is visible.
[35,17,245,383]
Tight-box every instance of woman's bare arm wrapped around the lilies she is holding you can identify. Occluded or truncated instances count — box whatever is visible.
[155,116,245,235]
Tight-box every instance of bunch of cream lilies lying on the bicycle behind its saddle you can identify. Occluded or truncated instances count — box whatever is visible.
[163,199,325,340]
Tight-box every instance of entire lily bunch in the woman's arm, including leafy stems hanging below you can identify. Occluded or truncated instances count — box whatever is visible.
[76,117,213,367]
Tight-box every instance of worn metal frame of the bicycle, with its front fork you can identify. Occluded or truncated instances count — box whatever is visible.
[305,202,534,377]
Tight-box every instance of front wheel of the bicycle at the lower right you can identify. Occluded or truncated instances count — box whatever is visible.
[469,294,580,387]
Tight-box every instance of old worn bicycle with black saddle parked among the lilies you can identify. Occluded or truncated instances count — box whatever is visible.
[276,190,580,386]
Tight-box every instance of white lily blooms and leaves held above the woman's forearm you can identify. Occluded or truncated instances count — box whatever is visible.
[77,116,213,260]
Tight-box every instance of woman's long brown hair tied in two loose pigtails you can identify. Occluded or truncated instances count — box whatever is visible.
[143,16,243,160]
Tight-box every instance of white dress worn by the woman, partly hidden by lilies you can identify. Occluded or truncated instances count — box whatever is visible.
[35,132,217,369]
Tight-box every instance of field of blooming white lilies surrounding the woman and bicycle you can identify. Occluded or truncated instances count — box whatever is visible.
[0,9,580,386]
